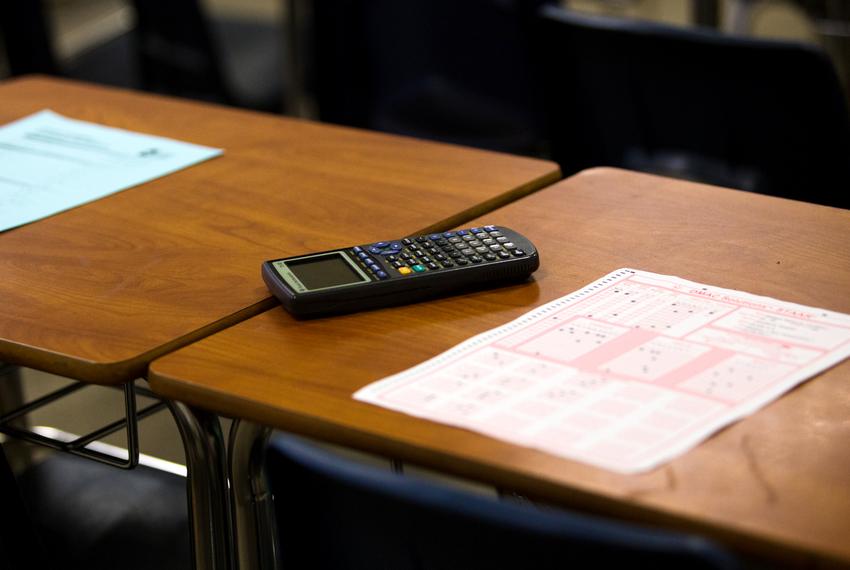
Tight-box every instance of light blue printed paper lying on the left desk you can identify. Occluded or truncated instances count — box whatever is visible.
[0,110,223,231]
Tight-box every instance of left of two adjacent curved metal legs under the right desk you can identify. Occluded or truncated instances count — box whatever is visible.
[168,402,235,570]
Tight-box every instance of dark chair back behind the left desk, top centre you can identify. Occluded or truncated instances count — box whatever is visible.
[305,0,544,154]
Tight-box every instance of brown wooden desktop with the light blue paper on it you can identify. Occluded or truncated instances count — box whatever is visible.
[0,77,560,383]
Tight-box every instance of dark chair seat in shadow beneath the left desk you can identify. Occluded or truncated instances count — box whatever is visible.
[10,452,192,570]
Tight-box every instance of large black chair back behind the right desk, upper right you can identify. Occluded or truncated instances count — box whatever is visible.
[535,6,850,208]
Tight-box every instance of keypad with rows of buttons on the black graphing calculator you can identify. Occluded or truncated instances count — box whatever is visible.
[350,226,526,279]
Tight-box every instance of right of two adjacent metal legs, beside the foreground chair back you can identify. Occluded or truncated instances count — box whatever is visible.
[228,420,279,570]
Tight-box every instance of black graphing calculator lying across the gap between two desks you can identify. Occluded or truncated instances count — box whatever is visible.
[263,226,540,317]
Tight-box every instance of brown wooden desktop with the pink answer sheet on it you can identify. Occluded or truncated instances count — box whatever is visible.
[150,169,850,565]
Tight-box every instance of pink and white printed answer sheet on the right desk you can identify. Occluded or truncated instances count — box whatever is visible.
[354,269,850,473]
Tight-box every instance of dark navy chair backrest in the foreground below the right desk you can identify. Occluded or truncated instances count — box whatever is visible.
[267,435,735,570]
